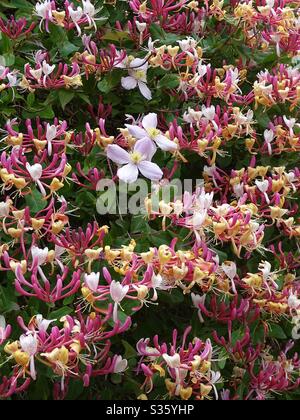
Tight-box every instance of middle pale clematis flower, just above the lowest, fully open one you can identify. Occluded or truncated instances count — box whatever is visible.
[126,113,177,152]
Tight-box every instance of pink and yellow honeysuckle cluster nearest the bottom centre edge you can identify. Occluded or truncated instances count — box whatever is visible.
[137,328,221,400]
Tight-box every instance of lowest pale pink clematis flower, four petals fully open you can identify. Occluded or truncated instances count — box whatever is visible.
[107,139,163,184]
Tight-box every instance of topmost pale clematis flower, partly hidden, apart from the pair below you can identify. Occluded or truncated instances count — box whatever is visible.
[116,58,152,100]
